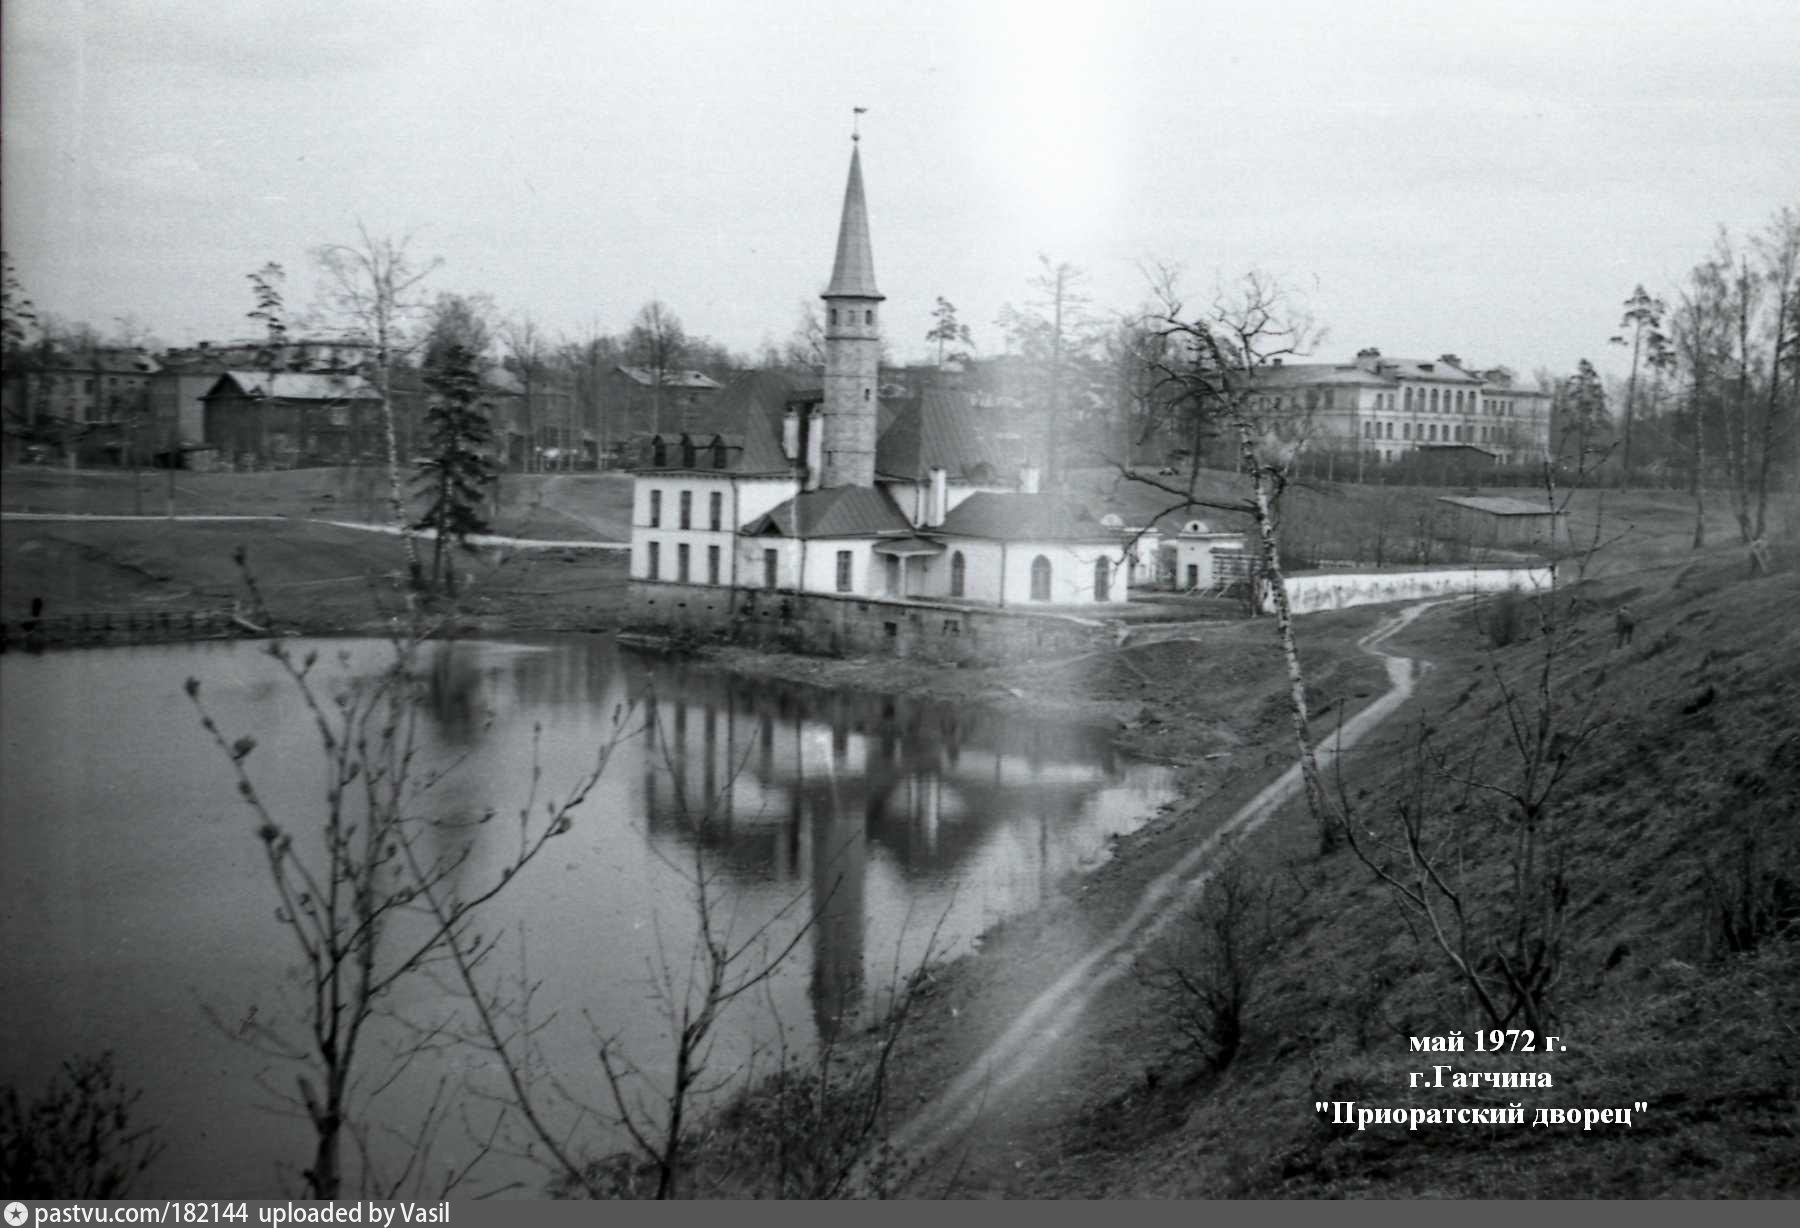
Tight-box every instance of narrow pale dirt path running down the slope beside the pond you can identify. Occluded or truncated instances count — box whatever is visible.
[891,598,1462,1170]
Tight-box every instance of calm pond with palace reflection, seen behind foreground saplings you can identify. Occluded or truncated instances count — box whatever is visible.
[0,637,1174,1197]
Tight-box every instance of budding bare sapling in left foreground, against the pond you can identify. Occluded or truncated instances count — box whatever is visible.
[187,586,612,1199]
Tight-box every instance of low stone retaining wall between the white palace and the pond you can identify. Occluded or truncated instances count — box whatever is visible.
[623,580,1116,664]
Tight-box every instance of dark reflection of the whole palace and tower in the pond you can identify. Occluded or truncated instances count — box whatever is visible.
[632,651,1121,1035]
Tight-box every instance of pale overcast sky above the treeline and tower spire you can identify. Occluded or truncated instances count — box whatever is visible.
[0,0,1800,371]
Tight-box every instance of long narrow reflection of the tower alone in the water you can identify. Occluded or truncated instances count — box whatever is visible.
[794,711,875,1041]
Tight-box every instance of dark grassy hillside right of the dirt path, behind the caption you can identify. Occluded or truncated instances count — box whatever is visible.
[963,551,1800,1197]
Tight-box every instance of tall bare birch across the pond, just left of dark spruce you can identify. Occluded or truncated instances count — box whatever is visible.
[313,221,443,582]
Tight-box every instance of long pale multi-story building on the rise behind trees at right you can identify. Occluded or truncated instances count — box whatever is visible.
[1258,349,1550,465]
